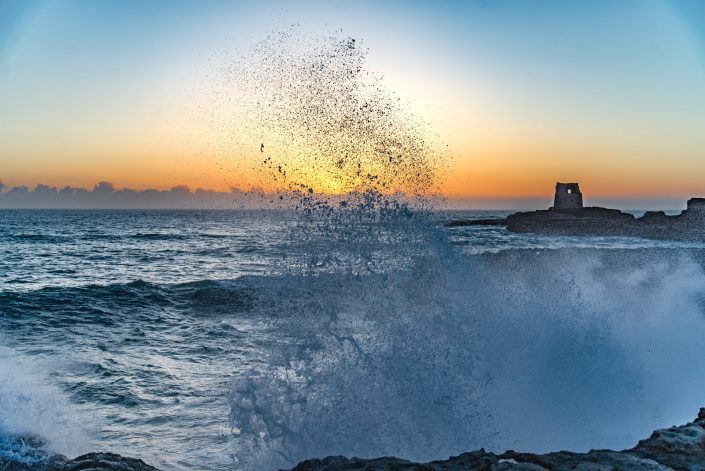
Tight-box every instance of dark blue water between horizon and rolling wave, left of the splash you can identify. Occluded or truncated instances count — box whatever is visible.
[0,210,293,289]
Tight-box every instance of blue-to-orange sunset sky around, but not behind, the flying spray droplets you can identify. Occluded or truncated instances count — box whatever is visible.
[0,0,705,207]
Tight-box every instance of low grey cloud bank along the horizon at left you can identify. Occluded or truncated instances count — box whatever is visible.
[0,180,270,209]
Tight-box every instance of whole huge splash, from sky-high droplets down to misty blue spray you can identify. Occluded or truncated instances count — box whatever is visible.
[220,28,705,469]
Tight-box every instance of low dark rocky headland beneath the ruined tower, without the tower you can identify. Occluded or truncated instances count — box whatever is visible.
[447,198,705,241]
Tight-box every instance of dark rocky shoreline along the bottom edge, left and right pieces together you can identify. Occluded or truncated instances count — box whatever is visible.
[12,408,705,471]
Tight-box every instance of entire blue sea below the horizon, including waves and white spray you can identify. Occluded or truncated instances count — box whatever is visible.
[0,210,705,470]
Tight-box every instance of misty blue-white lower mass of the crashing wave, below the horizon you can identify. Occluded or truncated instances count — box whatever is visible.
[230,216,705,468]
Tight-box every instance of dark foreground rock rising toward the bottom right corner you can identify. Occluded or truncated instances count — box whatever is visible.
[292,408,705,471]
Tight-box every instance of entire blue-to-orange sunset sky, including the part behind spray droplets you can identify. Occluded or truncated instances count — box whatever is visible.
[0,0,705,206]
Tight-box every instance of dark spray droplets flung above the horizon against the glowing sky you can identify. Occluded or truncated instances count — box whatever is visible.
[213,26,448,203]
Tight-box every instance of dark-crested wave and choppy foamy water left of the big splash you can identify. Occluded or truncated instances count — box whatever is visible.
[0,281,256,469]
